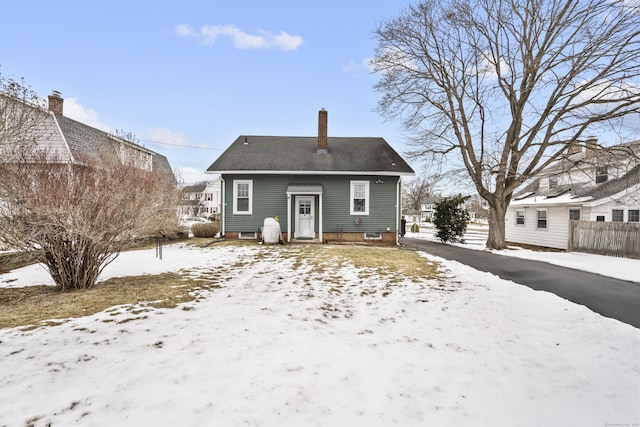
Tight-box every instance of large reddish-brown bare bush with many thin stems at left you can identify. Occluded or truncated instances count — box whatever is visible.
[0,152,177,291]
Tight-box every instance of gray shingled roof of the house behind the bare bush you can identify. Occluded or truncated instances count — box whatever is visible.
[52,114,176,182]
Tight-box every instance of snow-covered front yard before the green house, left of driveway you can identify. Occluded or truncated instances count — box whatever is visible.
[0,244,640,427]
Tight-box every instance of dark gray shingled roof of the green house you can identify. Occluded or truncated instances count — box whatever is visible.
[207,135,414,175]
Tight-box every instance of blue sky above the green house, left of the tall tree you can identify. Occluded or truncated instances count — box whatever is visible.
[0,0,416,183]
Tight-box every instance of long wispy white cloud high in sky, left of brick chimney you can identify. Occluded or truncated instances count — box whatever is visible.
[175,24,304,50]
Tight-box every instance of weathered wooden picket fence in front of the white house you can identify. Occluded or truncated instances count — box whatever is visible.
[568,221,640,259]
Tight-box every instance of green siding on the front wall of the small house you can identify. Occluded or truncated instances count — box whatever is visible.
[222,175,400,233]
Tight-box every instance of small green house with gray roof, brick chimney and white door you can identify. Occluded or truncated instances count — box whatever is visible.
[207,109,414,244]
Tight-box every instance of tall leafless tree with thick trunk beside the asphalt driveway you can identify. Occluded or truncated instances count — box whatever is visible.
[372,0,640,249]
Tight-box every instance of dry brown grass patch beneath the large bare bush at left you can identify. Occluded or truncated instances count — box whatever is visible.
[0,273,217,328]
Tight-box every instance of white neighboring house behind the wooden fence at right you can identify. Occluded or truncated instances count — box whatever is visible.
[505,138,640,250]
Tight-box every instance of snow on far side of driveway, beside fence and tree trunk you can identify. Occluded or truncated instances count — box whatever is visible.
[406,222,640,282]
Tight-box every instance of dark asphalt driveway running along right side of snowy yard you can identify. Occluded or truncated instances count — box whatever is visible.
[402,237,640,328]
